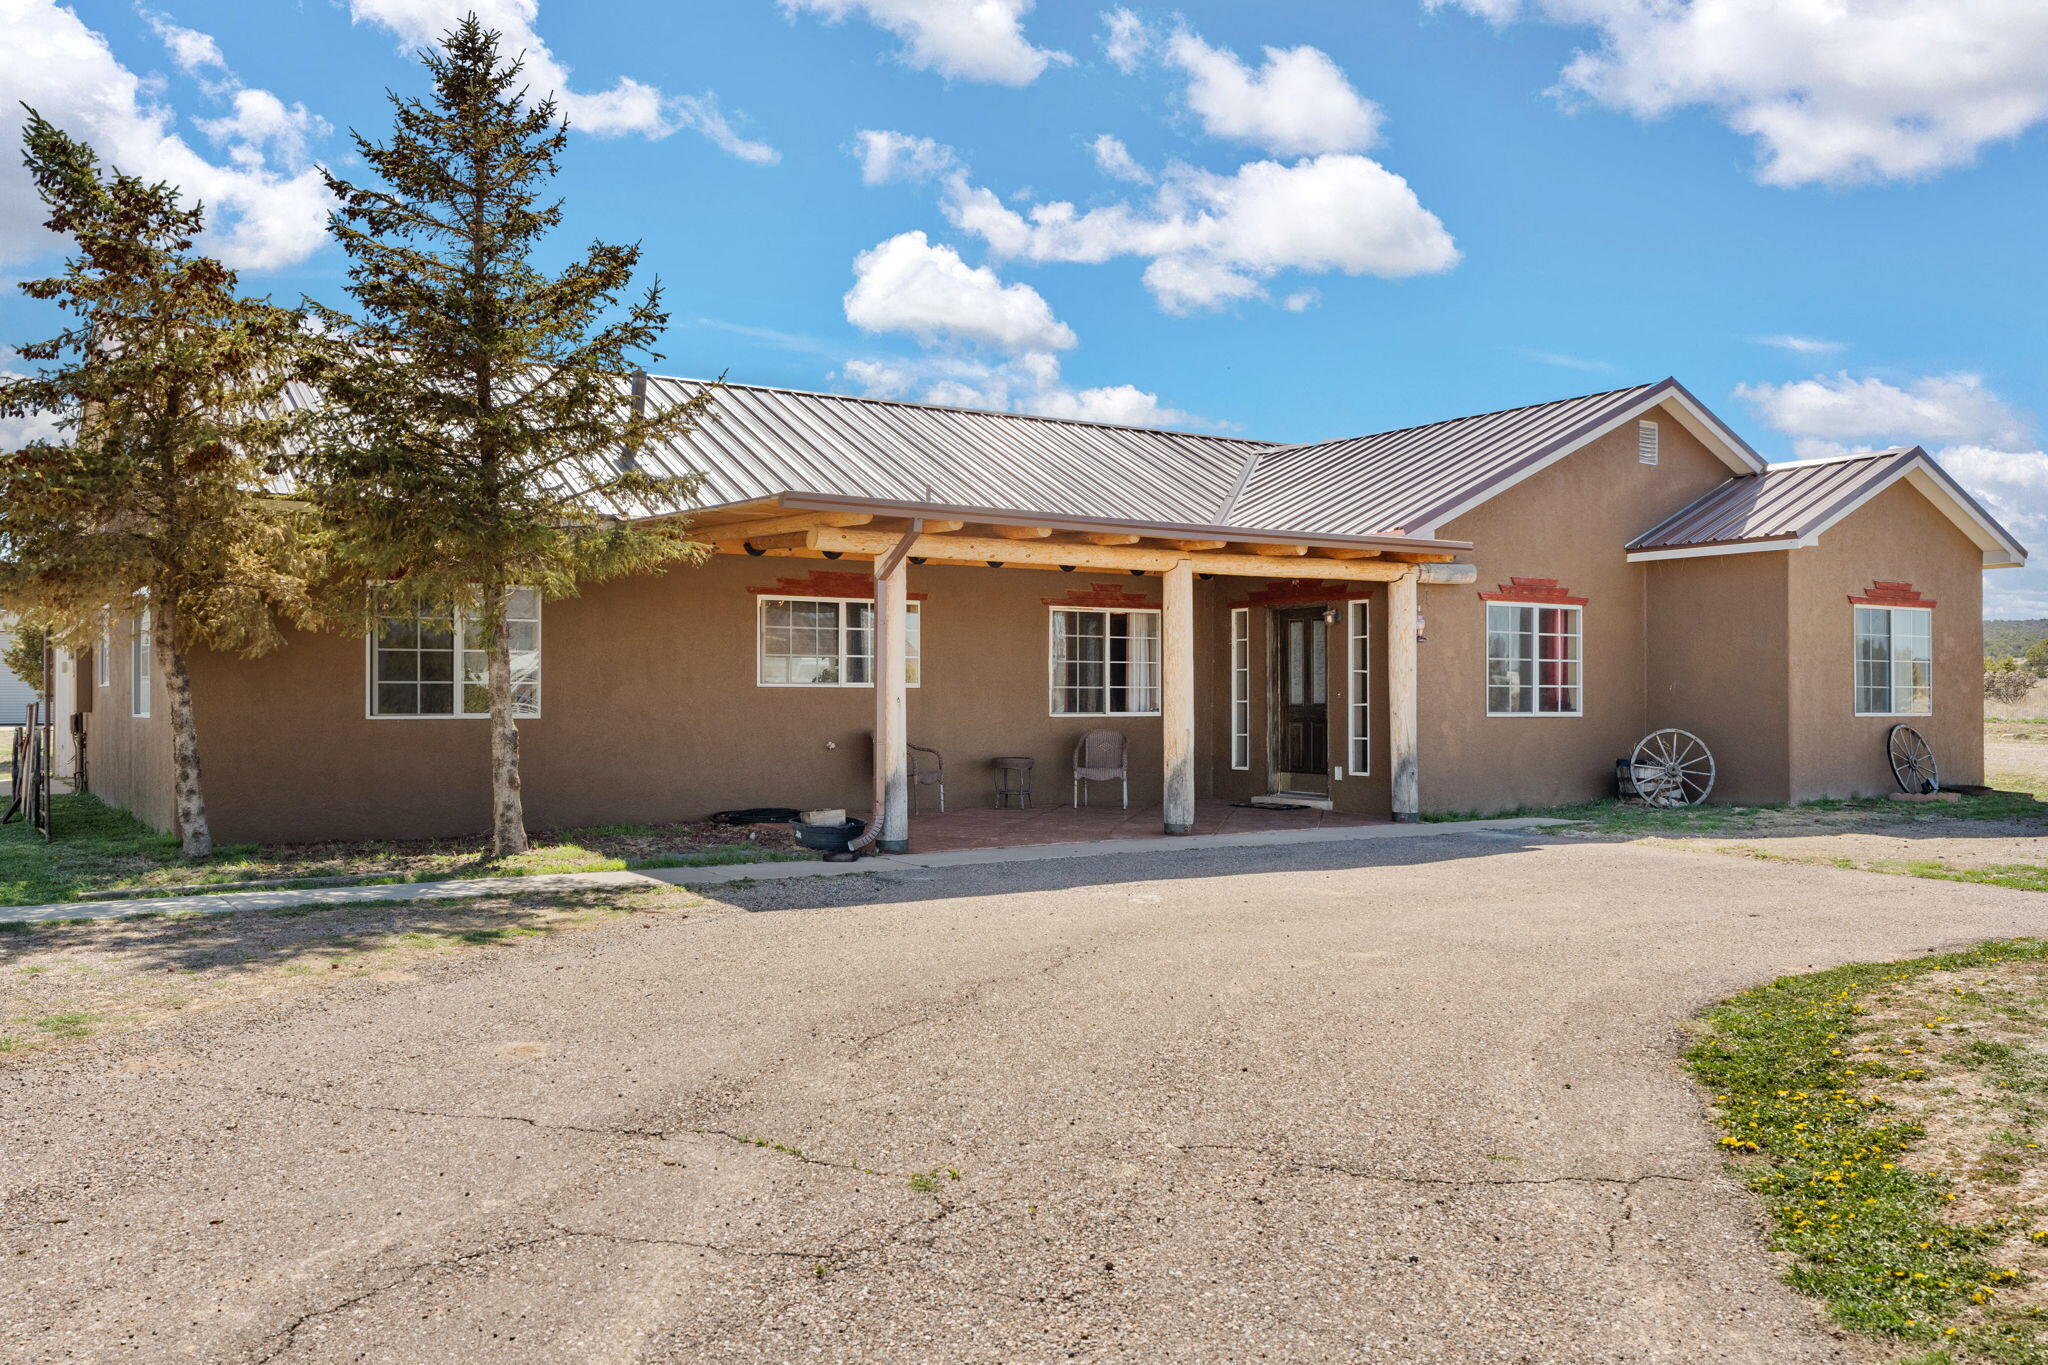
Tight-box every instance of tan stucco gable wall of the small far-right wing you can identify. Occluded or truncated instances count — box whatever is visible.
[1790,483,1985,800]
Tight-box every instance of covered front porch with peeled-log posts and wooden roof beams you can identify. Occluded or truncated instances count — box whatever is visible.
[694,493,1473,853]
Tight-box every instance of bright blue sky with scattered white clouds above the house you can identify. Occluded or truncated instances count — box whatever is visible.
[12,0,2048,614]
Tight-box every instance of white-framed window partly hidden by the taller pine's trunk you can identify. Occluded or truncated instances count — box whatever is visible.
[367,587,541,720]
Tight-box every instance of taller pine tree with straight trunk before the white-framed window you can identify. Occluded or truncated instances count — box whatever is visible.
[307,14,709,857]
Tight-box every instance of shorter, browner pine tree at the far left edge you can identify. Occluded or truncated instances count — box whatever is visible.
[0,108,313,857]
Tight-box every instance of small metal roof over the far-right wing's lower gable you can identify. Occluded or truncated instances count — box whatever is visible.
[1628,446,2028,567]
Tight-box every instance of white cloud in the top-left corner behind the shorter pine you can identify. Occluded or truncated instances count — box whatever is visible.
[0,0,328,270]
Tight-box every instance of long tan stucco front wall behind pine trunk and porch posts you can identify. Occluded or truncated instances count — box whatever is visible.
[172,557,1214,841]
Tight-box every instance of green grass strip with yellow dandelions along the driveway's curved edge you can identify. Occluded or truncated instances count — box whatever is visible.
[1686,939,2048,1365]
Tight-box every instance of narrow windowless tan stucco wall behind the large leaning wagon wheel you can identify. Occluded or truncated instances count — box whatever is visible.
[1645,551,1792,804]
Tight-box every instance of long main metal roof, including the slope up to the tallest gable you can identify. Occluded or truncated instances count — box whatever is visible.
[291,375,1810,556]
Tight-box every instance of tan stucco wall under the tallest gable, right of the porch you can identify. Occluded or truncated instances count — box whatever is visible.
[1417,409,1731,812]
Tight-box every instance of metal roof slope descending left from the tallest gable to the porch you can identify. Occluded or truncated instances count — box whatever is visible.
[1227,379,1728,534]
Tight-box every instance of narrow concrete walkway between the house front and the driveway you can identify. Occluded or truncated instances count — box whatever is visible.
[0,817,1565,923]
